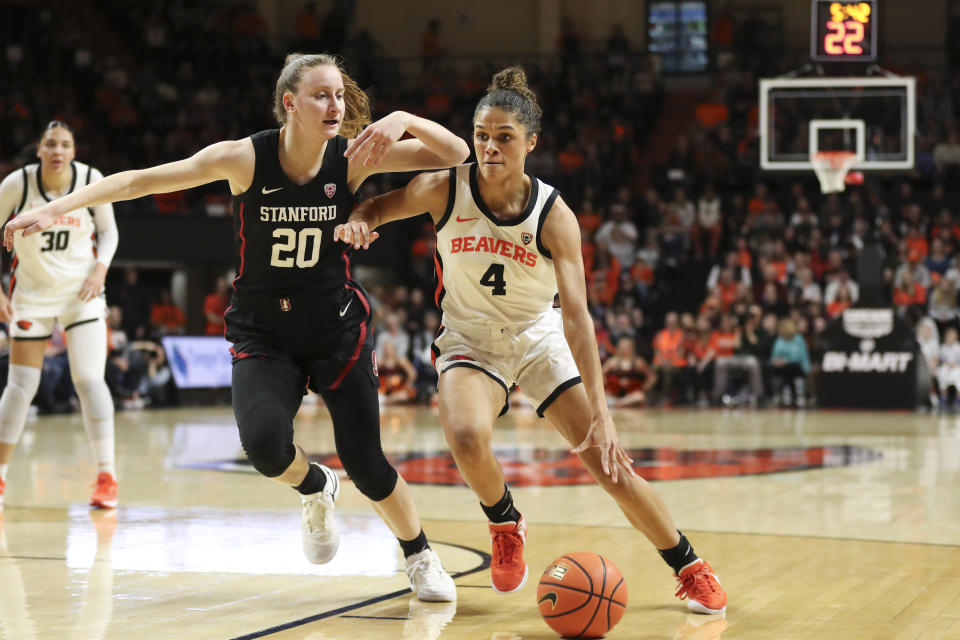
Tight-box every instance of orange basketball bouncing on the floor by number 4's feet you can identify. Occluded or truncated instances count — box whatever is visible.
[537,552,627,638]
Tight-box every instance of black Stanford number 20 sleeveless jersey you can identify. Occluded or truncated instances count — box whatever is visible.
[233,129,354,296]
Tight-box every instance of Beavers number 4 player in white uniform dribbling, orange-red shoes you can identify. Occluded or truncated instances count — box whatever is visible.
[335,67,727,613]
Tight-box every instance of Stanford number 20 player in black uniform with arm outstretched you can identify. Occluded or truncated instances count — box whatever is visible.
[4,54,469,600]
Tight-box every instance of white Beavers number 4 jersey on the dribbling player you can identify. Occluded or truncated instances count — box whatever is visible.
[436,164,559,327]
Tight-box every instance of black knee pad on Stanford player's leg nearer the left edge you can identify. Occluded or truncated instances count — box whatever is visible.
[237,402,297,478]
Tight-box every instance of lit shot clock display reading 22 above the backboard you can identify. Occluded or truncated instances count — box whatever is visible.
[810,0,877,62]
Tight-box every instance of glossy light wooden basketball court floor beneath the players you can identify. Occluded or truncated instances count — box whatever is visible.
[0,407,960,640]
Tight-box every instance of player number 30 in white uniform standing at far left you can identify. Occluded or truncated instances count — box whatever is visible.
[0,120,119,508]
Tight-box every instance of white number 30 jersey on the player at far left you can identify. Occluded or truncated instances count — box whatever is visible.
[10,162,100,308]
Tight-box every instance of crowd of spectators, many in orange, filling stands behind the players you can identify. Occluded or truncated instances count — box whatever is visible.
[0,0,960,406]
